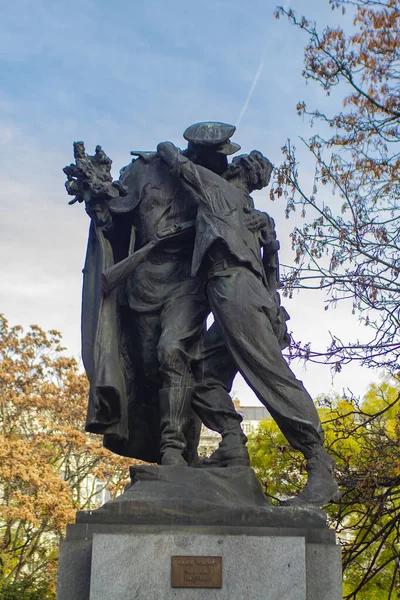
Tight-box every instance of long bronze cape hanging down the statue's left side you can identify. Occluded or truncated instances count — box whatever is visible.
[82,161,160,462]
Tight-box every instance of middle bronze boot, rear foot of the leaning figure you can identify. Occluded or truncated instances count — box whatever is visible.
[199,424,250,468]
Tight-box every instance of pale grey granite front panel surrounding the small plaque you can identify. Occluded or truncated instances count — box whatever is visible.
[90,534,307,600]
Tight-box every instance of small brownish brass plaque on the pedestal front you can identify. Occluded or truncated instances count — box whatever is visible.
[171,556,222,588]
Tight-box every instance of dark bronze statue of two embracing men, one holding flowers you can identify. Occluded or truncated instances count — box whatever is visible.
[65,122,338,505]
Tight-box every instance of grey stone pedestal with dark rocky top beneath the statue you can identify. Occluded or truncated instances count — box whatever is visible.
[57,467,342,600]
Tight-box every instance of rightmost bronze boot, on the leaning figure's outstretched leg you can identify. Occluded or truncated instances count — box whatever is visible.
[282,446,341,507]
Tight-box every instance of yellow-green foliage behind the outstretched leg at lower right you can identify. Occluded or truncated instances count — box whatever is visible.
[249,379,400,600]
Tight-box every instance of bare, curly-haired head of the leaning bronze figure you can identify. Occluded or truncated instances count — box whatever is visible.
[224,150,273,193]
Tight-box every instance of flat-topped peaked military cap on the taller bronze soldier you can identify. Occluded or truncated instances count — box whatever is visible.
[183,121,240,154]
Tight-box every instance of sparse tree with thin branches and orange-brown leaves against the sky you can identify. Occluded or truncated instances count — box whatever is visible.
[271,0,400,374]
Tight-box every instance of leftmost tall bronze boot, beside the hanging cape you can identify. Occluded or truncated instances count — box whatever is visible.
[159,387,192,466]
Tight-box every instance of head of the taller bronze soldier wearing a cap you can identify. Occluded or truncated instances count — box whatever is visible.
[183,121,240,175]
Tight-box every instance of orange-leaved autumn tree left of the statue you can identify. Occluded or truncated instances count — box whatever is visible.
[0,316,132,600]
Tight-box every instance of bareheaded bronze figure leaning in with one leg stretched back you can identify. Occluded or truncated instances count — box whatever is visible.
[157,136,339,505]
